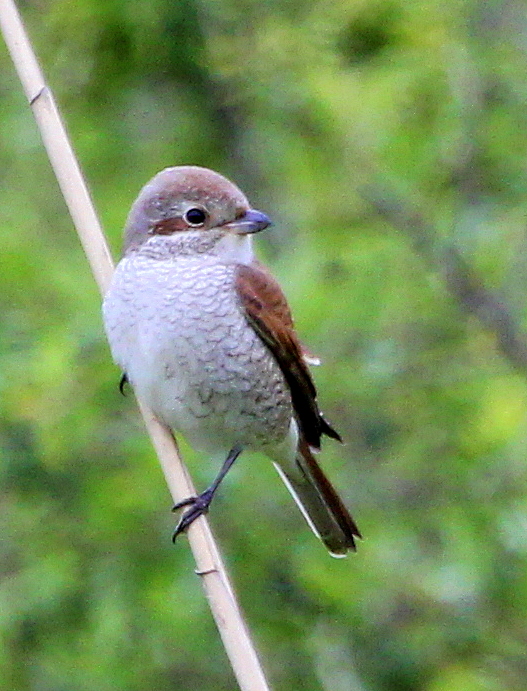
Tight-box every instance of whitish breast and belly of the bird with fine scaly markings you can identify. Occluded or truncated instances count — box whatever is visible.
[104,256,292,449]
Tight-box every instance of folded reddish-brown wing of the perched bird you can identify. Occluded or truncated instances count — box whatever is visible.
[236,262,341,449]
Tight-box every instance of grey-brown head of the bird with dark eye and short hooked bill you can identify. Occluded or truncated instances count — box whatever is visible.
[123,166,270,254]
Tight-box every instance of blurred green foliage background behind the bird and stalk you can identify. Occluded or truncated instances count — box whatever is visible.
[0,0,527,691]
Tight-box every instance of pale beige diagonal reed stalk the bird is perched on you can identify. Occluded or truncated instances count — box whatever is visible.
[0,0,269,691]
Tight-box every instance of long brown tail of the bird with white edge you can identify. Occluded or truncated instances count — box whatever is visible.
[274,441,362,557]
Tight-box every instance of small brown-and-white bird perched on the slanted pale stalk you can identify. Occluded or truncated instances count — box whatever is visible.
[103,165,361,557]
